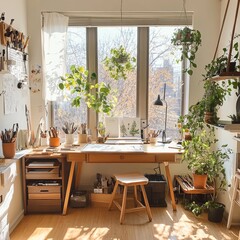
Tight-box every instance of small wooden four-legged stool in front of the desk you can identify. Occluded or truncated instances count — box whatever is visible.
[108,173,152,224]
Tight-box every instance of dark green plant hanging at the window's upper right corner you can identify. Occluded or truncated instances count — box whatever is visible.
[171,27,202,75]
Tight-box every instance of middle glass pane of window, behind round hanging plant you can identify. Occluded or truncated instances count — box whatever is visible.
[98,27,137,120]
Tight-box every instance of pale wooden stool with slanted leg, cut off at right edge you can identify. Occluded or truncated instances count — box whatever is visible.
[227,173,240,229]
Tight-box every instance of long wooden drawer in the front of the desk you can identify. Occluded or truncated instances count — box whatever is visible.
[87,153,155,163]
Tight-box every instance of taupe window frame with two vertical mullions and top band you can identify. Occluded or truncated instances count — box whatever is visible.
[49,12,189,139]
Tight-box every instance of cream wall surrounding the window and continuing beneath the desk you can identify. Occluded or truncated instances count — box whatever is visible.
[27,0,220,190]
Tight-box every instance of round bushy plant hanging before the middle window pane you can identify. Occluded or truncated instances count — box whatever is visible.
[103,45,136,80]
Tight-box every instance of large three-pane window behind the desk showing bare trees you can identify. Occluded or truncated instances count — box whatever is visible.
[52,23,183,138]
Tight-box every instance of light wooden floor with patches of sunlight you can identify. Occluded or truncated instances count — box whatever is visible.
[10,203,239,240]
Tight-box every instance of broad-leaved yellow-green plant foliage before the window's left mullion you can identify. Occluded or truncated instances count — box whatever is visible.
[59,65,114,114]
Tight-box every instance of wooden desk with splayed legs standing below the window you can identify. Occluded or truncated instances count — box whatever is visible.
[62,144,181,215]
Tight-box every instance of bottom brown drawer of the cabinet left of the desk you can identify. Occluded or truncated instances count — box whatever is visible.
[27,199,62,213]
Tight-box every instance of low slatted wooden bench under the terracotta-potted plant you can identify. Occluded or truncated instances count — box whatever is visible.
[175,175,214,194]
